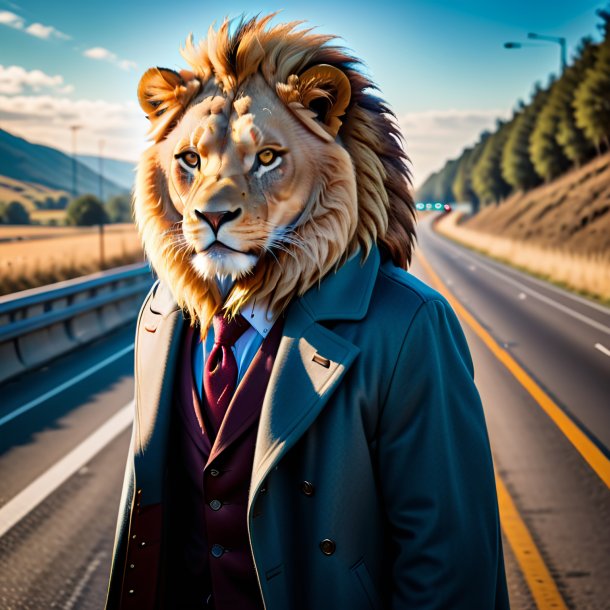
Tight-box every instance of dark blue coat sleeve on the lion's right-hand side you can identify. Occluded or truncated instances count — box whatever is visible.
[378,297,508,610]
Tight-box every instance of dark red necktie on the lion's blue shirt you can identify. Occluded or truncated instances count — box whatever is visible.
[203,314,250,432]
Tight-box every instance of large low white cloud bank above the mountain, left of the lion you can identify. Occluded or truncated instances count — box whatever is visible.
[0,95,148,160]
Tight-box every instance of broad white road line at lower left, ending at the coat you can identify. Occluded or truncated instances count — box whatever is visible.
[0,401,133,537]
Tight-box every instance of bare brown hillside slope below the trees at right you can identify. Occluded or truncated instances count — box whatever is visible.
[460,153,610,254]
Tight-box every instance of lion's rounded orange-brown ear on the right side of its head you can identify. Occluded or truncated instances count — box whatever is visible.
[299,64,352,139]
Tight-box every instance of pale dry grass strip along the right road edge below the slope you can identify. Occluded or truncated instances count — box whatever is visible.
[435,212,610,304]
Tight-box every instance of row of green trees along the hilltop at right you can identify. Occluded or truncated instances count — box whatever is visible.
[417,9,610,210]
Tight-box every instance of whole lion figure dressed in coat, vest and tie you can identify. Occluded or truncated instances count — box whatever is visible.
[106,15,509,610]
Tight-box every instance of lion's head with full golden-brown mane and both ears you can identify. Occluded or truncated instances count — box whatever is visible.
[134,15,414,330]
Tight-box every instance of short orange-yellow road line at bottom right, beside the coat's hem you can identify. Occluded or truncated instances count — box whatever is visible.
[496,473,568,610]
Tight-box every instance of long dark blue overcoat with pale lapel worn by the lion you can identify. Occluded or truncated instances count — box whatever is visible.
[107,249,509,610]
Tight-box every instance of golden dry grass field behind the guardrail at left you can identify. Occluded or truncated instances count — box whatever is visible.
[0,224,144,294]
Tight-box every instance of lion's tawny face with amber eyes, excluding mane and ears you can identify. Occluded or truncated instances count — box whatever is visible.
[159,75,324,280]
